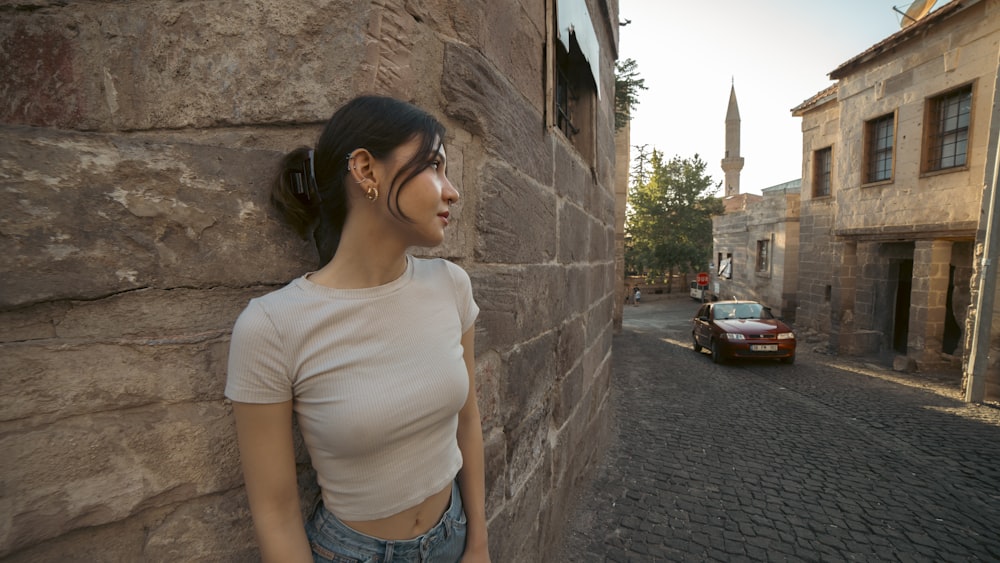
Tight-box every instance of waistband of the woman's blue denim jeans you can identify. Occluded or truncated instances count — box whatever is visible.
[311,481,464,562]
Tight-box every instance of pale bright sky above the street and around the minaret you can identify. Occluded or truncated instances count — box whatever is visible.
[618,0,947,195]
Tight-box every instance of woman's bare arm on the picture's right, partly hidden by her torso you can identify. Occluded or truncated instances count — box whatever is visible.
[458,328,490,563]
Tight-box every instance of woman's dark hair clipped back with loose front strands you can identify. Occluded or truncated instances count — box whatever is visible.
[271,96,445,264]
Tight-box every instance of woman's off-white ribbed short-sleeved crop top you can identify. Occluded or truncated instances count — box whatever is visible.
[226,256,479,521]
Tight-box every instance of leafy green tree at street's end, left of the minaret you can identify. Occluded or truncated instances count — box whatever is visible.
[625,147,724,283]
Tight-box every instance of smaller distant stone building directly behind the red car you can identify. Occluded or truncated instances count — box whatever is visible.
[710,180,799,321]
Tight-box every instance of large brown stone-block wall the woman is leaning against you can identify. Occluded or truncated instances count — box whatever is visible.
[0,0,618,562]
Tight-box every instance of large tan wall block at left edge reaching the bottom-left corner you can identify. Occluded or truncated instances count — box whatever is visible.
[0,401,242,555]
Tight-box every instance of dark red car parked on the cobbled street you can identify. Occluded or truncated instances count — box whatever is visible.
[691,301,795,364]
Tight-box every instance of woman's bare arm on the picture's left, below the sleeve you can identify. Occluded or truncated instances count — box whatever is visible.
[233,401,313,563]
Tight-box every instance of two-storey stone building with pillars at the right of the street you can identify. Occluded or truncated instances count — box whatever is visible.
[792,0,1000,392]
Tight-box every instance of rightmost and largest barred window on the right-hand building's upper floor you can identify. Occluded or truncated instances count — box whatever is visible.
[923,84,972,172]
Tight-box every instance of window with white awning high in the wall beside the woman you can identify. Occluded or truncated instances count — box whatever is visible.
[548,0,600,162]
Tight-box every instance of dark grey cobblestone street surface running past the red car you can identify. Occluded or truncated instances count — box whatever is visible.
[560,298,1000,563]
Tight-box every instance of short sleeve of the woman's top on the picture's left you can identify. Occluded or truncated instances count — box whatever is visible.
[226,300,293,403]
